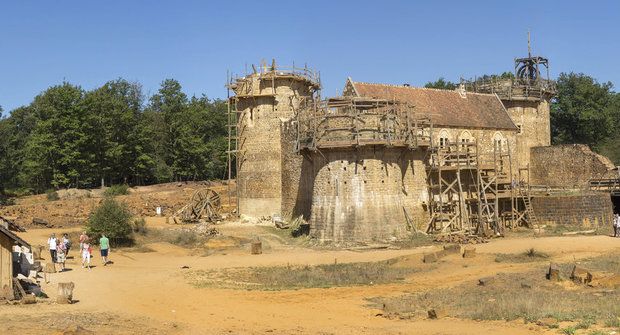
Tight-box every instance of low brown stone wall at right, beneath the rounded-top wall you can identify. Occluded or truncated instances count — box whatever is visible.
[532,193,613,228]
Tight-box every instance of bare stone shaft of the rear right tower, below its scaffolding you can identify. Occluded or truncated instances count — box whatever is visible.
[502,99,551,168]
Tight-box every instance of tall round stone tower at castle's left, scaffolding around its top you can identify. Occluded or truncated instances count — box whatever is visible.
[228,61,320,217]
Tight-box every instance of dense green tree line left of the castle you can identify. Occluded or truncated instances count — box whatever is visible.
[0,79,227,197]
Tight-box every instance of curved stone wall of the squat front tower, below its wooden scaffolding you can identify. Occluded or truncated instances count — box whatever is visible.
[311,147,426,242]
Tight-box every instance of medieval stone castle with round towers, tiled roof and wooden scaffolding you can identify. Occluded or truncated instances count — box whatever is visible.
[228,51,610,243]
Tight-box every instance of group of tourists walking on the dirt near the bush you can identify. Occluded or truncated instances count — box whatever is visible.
[47,231,110,272]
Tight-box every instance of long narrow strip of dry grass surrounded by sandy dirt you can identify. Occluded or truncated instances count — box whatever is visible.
[188,260,415,290]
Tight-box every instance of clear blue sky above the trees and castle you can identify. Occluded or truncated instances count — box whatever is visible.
[0,0,620,111]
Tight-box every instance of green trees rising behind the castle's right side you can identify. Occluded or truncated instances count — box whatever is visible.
[424,72,620,165]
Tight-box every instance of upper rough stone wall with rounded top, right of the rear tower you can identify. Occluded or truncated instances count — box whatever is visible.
[530,144,617,188]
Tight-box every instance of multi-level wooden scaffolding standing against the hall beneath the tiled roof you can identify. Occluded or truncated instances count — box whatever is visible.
[426,141,516,234]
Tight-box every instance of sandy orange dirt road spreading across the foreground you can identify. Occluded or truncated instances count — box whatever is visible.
[0,229,620,334]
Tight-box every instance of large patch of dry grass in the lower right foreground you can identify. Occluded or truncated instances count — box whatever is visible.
[370,254,620,326]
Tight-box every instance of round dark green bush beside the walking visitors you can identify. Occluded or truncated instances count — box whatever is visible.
[87,198,133,245]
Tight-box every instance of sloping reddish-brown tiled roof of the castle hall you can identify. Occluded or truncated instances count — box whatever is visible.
[350,81,517,130]
